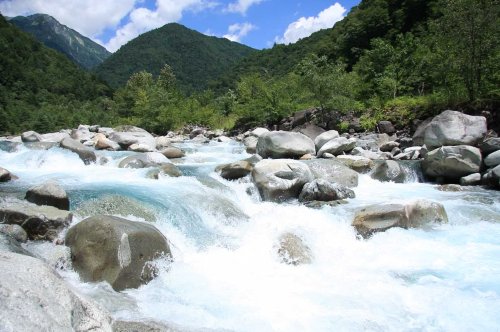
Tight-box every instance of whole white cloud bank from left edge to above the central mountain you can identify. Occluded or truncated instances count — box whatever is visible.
[0,0,218,52]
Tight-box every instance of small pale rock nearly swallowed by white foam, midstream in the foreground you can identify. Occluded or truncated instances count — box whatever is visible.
[278,233,312,265]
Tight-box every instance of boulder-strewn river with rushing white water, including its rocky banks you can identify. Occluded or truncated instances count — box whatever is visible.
[0,111,500,331]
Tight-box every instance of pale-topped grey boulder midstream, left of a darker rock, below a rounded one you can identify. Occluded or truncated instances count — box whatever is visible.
[252,159,313,202]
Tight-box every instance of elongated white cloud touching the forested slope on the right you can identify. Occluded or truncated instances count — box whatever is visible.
[275,2,346,44]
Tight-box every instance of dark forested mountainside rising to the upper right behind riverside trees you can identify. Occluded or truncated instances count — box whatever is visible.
[218,0,440,86]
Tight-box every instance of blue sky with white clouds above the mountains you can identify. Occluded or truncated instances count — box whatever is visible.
[0,0,359,51]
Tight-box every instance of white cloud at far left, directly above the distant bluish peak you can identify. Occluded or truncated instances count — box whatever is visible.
[0,0,136,38]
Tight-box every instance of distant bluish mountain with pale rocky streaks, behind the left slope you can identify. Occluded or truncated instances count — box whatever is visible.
[10,14,111,69]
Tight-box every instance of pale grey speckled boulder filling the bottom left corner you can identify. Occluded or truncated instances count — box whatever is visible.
[0,252,112,332]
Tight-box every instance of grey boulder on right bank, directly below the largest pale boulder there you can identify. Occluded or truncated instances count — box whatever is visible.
[422,145,482,179]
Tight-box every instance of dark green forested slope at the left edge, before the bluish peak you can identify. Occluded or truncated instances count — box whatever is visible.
[0,15,111,133]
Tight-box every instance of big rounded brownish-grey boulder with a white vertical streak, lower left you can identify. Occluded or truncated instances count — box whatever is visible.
[66,216,171,291]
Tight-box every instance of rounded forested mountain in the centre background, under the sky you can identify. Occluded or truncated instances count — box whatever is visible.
[97,23,255,91]
